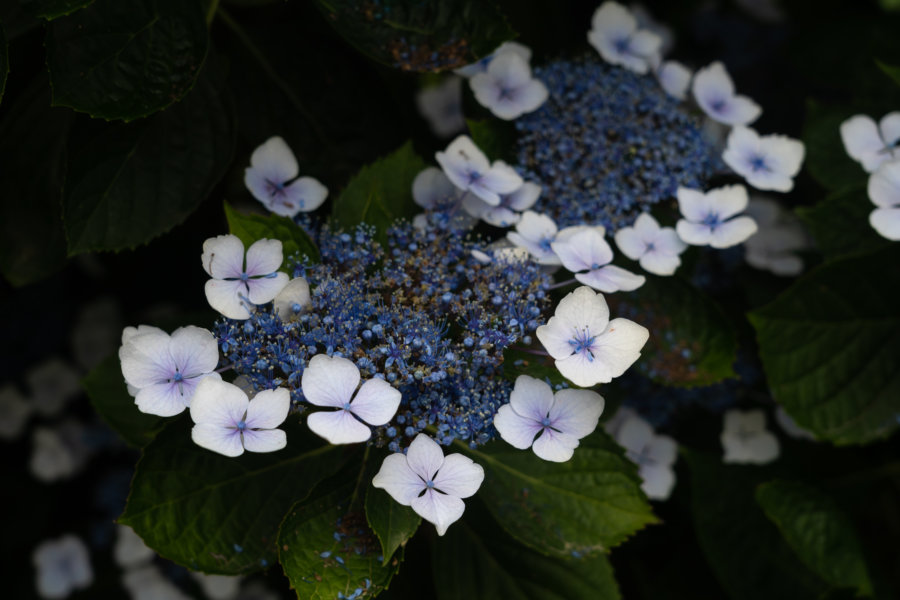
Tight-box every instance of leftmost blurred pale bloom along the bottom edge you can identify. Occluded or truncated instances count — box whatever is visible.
[31,534,94,598]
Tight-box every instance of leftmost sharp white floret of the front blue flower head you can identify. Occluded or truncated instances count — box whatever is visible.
[119,325,221,417]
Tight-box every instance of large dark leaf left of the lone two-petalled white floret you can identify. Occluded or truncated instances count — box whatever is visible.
[63,62,234,255]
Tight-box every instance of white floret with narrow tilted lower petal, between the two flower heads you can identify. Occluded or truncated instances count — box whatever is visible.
[550,226,646,294]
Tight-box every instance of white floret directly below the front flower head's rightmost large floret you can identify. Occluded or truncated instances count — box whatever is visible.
[494,375,604,462]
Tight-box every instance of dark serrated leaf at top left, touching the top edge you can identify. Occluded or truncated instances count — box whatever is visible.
[46,0,209,121]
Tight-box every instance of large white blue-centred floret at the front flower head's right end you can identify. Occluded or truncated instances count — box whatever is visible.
[535,287,650,387]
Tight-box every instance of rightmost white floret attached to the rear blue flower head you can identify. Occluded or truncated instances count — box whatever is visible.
[722,125,805,192]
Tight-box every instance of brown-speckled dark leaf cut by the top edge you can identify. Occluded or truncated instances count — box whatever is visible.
[316,0,515,72]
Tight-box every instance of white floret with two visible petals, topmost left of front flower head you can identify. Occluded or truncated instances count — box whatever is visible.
[244,136,328,217]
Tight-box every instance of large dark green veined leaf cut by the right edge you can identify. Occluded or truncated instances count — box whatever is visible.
[749,244,900,445]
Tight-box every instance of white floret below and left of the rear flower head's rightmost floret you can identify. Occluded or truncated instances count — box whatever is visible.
[675,185,756,248]
